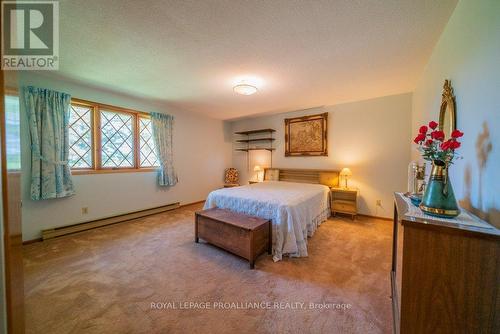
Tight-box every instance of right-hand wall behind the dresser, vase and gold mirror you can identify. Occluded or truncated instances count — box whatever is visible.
[412,0,500,223]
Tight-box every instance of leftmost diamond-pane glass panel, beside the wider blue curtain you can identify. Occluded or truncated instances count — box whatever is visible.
[68,104,93,168]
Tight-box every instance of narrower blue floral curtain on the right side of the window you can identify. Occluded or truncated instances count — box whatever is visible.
[151,112,178,186]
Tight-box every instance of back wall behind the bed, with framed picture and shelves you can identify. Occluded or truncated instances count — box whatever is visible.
[232,94,412,217]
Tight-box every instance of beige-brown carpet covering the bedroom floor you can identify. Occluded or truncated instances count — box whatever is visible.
[25,205,392,333]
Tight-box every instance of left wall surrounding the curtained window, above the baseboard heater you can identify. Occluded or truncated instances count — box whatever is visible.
[14,72,231,240]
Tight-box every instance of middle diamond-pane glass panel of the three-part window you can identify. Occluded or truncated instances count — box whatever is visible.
[101,110,134,168]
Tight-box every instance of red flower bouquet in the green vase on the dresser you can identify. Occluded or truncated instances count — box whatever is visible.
[413,121,464,164]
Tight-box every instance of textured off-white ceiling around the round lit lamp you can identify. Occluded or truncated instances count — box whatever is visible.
[59,0,456,119]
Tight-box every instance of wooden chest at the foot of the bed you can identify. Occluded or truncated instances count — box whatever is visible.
[195,208,272,269]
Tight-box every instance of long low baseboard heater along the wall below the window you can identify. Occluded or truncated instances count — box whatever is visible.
[42,202,180,240]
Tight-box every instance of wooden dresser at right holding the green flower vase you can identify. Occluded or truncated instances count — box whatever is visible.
[391,193,500,334]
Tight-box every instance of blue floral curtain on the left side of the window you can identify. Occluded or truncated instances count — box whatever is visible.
[23,86,75,200]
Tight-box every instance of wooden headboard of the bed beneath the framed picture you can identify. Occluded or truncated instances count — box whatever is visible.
[264,168,339,187]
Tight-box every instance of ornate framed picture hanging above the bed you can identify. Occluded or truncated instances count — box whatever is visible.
[285,113,328,157]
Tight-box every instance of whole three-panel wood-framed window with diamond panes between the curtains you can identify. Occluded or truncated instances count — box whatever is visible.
[69,99,159,174]
